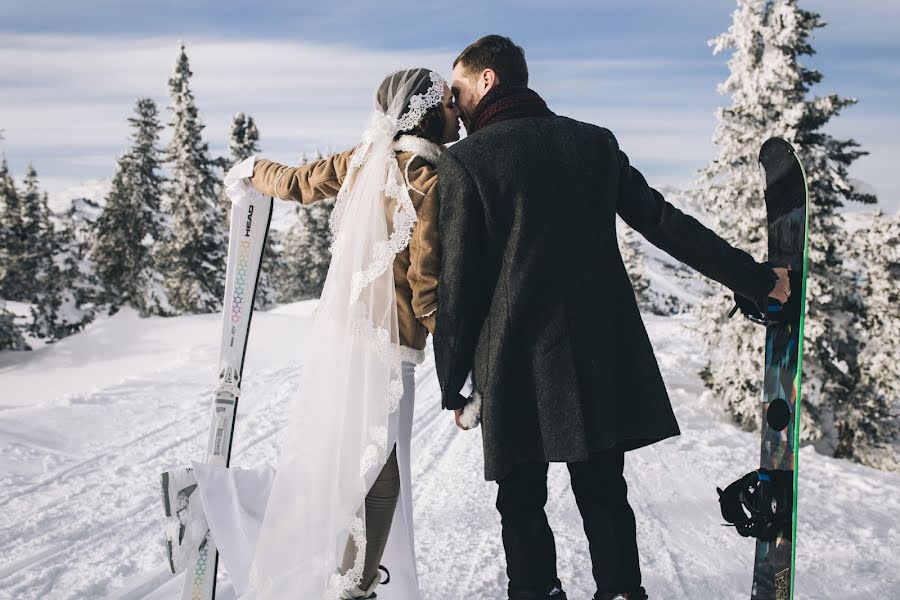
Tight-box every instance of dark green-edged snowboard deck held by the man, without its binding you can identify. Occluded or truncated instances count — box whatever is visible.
[751,138,809,600]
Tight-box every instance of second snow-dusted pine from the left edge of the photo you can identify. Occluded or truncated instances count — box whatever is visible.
[21,165,94,342]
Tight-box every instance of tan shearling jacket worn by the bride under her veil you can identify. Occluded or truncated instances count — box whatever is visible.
[251,136,441,350]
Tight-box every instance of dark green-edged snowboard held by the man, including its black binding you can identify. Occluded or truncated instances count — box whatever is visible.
[719,138,809,600]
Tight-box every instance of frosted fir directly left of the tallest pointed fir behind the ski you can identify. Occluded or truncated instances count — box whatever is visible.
[91,98,172,315]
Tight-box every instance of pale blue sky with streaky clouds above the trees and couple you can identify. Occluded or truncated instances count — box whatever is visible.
[0,0,900,210]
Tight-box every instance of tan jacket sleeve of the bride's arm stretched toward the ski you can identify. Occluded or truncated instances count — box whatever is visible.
[250,149,353,204]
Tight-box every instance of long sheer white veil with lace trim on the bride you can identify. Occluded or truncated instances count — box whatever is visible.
[247,69,445,600]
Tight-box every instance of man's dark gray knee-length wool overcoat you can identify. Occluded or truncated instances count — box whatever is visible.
[434,116,775,480]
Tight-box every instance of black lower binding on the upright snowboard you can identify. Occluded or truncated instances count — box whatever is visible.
[716,468,794,541]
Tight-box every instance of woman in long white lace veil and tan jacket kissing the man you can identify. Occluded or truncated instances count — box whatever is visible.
[165,69,459,600]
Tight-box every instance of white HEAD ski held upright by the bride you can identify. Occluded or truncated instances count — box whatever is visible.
[181,191,273,600]
